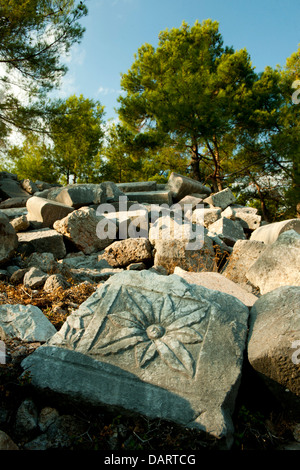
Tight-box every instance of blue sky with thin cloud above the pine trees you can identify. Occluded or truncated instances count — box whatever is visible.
[56,0,300,120]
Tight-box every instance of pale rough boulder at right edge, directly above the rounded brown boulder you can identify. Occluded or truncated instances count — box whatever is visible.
[246,230,300,294]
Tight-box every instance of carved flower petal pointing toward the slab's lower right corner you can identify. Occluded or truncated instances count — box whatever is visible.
[155,336,194,377]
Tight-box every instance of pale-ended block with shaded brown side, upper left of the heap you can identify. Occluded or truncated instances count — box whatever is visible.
[26,196,74,228]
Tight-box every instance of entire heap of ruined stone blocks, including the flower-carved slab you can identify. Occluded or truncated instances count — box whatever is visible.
[0,172,300,449]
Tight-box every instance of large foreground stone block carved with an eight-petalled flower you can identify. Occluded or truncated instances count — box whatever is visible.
[22,271,249,446]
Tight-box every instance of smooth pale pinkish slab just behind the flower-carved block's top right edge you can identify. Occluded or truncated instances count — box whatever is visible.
[174,267,257,307]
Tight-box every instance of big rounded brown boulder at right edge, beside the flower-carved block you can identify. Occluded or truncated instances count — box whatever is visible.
[248,286,300,412]
